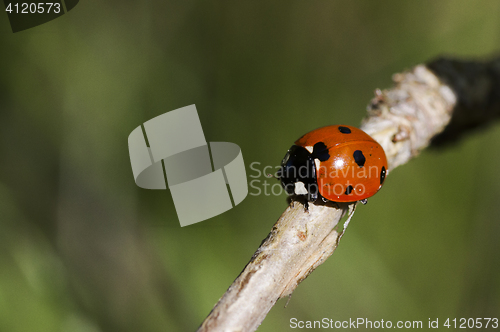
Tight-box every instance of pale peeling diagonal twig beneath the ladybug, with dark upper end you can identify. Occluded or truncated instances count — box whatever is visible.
[198,59,500,332]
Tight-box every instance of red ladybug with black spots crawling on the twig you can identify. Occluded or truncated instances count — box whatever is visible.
[277,125,389,209]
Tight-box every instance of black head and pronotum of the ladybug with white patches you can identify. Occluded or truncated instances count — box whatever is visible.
[277,145,318,202]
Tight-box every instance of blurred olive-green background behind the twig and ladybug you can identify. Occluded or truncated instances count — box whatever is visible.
[0,0,500,332]
